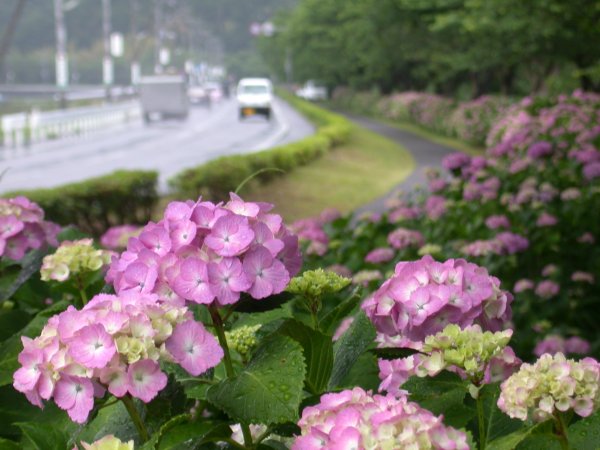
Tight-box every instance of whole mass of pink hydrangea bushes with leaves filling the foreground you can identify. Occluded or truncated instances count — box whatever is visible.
[0,89,600,450]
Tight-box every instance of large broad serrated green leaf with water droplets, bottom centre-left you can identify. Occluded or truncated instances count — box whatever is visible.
[208,336,306,424]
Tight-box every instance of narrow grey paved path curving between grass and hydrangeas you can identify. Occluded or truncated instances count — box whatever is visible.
[345,114,457,215]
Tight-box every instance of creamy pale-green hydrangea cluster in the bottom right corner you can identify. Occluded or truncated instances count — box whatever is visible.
[498,353,600,422]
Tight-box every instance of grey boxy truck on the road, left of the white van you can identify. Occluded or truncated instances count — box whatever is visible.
[140,75,190,122]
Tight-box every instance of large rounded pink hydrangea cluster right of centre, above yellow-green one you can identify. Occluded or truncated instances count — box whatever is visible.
[362,256,513,349]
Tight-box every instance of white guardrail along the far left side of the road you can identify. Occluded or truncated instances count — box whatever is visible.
[0,101,142,148]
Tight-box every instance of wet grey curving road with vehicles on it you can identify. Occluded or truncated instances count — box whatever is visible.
[0,99,314,192]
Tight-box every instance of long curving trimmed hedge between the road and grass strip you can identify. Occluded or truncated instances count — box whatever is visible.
[169,92,351,200]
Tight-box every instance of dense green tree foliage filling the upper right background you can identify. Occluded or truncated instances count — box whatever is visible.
[261,0,600,96]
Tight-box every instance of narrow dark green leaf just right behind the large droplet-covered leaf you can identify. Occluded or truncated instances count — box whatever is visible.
[277,319,333,394]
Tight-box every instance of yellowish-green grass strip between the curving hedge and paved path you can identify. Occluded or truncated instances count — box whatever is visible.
[240,126,415,222]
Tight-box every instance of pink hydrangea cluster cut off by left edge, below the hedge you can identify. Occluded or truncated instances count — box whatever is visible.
[0,197,60,261]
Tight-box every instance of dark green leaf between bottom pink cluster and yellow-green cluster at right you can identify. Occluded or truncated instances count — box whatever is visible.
[402,371,475,428]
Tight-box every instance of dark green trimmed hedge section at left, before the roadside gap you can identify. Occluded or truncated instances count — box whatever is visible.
[4,170,159,236]
